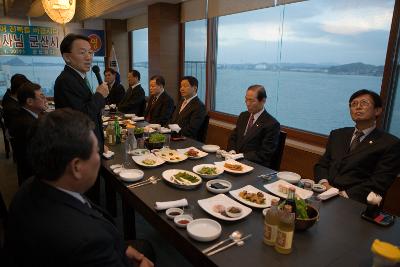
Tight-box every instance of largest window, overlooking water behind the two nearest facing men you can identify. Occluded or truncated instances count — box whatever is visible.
[215,0,394,134]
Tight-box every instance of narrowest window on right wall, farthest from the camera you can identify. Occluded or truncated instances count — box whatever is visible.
[132,28,149,95]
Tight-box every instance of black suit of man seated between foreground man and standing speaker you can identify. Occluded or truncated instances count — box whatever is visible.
[10,108,37,185]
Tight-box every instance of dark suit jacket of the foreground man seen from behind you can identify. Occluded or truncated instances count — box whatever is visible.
[5,179,129,267]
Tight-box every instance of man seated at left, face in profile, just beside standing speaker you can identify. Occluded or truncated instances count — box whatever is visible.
[10,82,47,185]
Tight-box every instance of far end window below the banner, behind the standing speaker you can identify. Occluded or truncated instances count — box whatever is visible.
[0,56,104,97]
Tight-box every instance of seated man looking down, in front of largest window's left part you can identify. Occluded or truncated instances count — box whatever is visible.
[228,85,280,167]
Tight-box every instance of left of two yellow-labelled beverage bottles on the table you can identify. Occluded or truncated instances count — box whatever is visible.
[264,199,280,246]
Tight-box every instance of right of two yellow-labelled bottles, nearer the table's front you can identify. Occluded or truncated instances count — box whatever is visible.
[275,205,295,254]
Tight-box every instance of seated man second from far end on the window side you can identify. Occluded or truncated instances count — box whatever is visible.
[118,70,146,116]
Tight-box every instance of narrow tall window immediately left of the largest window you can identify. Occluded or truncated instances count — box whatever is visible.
[185,20,207,102]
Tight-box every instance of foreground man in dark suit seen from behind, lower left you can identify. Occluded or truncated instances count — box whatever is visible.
[5,108,153,266]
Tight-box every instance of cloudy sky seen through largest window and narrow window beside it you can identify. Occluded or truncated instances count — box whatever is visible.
[185,0,394,65]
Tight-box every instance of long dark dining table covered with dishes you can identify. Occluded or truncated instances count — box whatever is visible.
[100,129,400,267]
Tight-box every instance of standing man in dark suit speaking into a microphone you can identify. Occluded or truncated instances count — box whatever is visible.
[54,33,109,202]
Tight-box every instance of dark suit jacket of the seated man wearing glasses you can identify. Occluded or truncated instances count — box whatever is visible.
[314,127,400,203]
